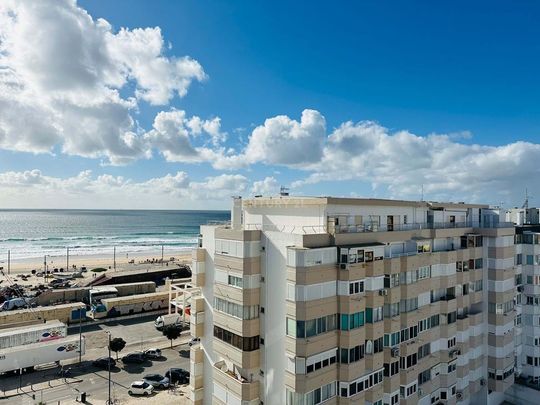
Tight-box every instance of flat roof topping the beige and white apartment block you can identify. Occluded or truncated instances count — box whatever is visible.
[242,196,489,209]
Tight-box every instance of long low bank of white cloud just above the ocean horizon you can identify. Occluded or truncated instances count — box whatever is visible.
[0,169,249,209]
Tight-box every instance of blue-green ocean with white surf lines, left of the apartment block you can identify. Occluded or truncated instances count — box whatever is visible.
[0,210,230,260]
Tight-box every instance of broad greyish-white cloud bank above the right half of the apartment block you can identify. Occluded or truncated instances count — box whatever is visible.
[293,121,540,202]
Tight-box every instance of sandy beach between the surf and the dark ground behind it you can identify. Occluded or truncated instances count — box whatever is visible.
[0,250,191,288]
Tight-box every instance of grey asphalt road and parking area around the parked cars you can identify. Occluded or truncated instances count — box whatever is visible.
[0,317,189,405]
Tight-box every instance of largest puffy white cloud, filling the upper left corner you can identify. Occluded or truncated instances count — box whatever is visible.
[0,0,205,164]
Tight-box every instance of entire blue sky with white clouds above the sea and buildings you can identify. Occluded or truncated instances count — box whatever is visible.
[0,0,540,209]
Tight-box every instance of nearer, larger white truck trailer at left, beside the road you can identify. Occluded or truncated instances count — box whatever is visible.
[0,336,85,374]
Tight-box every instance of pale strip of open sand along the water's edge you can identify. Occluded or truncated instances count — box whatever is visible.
[0,248,191,274]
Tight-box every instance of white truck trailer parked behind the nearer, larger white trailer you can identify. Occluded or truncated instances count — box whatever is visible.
[0,321,67,349]
